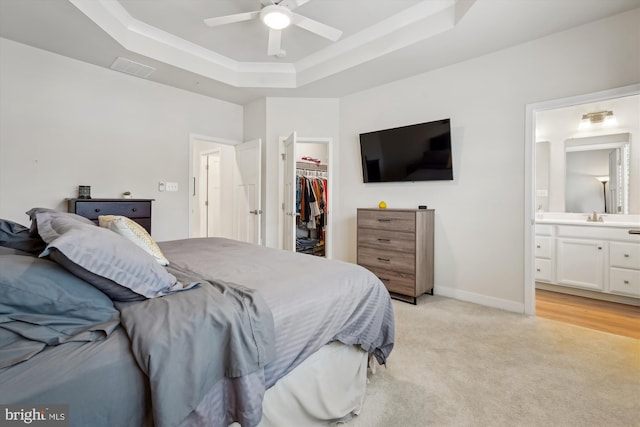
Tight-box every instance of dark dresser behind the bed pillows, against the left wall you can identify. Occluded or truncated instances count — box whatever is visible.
[67,199,154,234]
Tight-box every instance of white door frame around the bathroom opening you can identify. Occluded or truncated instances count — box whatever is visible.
[524,84,640,315]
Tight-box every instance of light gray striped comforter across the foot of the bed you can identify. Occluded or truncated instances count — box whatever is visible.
[160,238,394,427]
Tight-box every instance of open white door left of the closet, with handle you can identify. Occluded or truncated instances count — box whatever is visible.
[234,139,262,244]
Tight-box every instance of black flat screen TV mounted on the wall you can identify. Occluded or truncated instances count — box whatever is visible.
[360,119,453,182]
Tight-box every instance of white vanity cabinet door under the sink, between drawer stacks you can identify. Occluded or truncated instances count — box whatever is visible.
[556,238,605,290]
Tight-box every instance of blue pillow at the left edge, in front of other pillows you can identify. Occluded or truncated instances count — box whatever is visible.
[0,251,120,367]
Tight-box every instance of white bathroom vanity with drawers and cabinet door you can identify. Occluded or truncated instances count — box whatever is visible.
[535,213,640,305]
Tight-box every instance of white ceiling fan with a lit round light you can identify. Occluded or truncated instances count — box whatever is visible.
[204,0,342,58]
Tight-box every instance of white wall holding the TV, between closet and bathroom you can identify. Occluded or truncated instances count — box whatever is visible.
[334,10,640,311]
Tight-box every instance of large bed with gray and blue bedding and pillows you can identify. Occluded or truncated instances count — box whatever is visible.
[0,208,394,427]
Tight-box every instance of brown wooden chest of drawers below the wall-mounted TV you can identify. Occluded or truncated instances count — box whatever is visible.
[358,209,435,304]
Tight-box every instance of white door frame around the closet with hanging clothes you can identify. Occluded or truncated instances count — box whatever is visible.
[278,136,335,259]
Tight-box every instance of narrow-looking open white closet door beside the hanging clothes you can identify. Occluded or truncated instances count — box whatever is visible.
[282,132,296,251]
